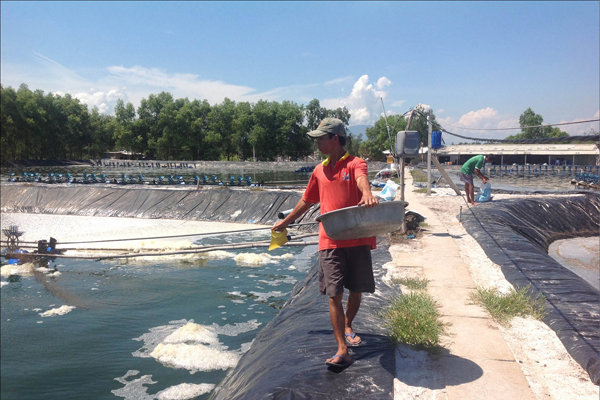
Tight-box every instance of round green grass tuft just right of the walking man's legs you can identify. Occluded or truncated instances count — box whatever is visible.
[382,292,445,353]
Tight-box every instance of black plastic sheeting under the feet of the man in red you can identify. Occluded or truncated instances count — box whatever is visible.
[211,241,400,400]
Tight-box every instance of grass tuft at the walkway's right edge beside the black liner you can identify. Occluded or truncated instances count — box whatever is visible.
[471,286,546,326]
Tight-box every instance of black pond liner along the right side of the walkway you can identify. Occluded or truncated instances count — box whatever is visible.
[462,194,600,385]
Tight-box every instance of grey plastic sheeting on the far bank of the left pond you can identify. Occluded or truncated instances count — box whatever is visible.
[0,185,319,228]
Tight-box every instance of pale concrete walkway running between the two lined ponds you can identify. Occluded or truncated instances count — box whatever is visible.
[394,179,535,400]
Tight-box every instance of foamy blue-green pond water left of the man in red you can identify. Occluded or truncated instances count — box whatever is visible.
[0,214,316,399]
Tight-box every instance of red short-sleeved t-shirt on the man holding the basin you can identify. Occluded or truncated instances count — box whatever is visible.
[302,153,377,251]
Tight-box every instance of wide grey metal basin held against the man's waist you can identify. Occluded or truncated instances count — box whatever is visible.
[317,201,408,240]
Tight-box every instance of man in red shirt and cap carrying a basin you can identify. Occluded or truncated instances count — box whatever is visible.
[273,118,379,367]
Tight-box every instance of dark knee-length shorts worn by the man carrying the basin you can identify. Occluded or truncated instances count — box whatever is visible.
[319,245,375,297]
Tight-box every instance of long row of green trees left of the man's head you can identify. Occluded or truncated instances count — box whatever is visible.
[0,84,360,161]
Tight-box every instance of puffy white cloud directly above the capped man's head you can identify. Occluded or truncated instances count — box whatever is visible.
[321,75,392,125]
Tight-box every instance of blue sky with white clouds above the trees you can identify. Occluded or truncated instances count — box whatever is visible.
[0,1,600,143]
